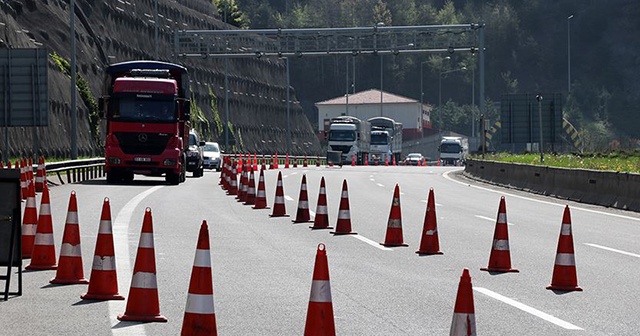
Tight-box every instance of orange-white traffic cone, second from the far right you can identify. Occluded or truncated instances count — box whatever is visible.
[480,196,519,272]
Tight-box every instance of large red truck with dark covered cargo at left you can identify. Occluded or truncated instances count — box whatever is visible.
[98,61,196,185]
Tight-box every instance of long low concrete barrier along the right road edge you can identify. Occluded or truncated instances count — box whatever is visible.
[464,159,640,212]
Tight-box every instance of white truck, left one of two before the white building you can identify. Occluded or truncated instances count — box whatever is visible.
[328,116,371,164]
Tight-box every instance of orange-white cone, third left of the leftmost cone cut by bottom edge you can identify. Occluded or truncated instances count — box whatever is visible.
[49,191,89,285]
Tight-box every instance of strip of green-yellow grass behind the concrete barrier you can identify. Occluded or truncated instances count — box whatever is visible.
[474,150,640,173]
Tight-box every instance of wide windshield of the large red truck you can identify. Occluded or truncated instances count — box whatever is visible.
[111,98,177,122]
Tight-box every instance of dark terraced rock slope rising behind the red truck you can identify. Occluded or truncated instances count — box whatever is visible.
[0,0,321,157]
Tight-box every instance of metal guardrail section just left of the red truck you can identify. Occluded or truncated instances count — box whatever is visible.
[43,158,104,184]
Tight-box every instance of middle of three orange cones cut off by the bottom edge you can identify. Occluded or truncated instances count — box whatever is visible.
[304,243,336,336]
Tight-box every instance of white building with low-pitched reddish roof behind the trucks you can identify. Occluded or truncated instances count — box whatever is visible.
[315,89,431,140]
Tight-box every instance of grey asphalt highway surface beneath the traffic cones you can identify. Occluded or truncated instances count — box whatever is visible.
[0,166,640,336]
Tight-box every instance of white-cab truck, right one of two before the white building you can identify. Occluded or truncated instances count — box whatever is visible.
[368,117,402,164]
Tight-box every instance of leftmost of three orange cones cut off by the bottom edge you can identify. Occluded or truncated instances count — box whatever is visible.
[180,221,218,336]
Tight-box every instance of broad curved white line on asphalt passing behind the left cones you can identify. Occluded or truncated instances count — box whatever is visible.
[109,186,164,336]
